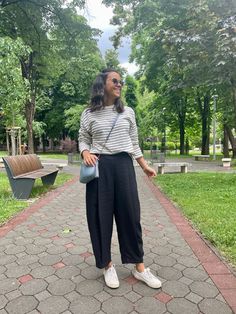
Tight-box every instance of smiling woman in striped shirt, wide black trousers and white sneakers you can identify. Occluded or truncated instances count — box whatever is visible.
[79,69,161,288]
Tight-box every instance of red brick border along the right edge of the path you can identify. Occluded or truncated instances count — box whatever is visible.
[144,177,236,313]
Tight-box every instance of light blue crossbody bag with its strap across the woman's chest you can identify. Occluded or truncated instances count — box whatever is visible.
[79,114,119,184]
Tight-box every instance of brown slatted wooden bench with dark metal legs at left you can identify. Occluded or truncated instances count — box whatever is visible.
[2,154,58,199]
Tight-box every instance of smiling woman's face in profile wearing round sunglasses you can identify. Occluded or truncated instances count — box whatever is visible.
[104,72,123,99]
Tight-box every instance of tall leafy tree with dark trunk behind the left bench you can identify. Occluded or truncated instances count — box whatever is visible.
[0,0,95,152]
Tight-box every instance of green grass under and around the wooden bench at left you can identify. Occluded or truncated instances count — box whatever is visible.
[0,173,73,225]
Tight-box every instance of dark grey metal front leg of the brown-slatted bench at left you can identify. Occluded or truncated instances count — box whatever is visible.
[10,179,35,200]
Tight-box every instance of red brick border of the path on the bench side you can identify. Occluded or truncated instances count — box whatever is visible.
[0,176,79,237]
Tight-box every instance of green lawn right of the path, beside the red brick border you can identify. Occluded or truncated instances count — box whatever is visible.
[155,173,236,266]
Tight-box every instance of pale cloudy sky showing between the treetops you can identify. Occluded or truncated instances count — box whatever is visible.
[80,0,137,75]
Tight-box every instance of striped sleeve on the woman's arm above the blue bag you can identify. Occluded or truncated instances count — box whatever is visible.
[79,110,92,153]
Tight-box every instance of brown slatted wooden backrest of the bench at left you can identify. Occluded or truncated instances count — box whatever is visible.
[3,154,43,177]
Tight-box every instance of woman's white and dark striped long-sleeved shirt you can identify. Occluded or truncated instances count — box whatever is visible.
[79,106,143,159]
